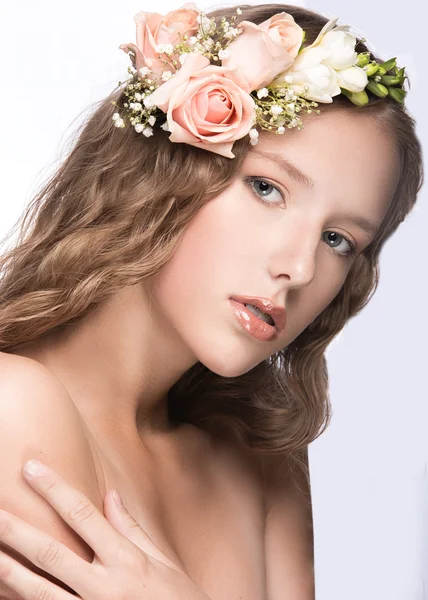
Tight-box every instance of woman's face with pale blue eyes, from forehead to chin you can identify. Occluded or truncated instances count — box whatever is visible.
[152,111,398,377]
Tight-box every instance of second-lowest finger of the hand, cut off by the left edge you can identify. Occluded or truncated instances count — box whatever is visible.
[0,510,94,593]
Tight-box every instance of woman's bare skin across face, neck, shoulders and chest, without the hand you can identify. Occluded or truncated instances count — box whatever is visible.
[0,110,399,600]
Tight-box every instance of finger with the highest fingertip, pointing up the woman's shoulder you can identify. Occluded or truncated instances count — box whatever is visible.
[22,461,129,564]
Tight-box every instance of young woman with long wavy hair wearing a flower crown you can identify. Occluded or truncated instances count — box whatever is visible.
[0,4,422,600]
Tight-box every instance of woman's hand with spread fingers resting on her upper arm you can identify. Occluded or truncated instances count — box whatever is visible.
[0,461,209,600]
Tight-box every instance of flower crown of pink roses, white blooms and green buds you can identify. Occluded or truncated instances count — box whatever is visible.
[113,2,407,158]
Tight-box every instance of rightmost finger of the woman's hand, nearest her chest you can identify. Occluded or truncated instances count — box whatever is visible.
[104,489,181,569]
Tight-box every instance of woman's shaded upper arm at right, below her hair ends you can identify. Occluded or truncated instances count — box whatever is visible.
[262,452,315,600]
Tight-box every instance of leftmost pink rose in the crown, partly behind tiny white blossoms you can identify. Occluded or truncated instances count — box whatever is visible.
[120,2,200,79]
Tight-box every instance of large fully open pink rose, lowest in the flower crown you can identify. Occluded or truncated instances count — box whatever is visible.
[150,52,255,158]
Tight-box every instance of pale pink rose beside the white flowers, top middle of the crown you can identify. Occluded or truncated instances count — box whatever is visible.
[221,12,303,90]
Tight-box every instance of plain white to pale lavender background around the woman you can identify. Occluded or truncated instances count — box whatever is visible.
[0,0,428,600]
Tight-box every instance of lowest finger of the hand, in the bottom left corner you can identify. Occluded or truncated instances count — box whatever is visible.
[0,551,76,600]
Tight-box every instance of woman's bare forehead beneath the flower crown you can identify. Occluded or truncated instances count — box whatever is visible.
[246,111,399,217]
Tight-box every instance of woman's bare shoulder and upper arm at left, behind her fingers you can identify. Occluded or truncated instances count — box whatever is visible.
[0,352,103,558]
